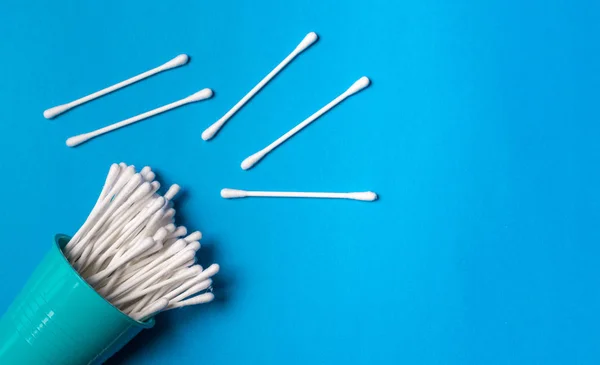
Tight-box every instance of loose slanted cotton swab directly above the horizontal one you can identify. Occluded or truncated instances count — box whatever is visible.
[241,76,371,170]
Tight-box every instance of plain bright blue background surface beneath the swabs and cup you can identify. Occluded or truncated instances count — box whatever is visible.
[0,0,600,364]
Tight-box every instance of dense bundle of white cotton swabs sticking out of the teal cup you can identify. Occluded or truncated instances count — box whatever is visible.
[64,163,219,321]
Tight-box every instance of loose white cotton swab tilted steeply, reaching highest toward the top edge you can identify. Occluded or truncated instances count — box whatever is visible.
[202,32,319,141]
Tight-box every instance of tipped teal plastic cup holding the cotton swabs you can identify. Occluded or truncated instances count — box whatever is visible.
[0,235,154,365]
